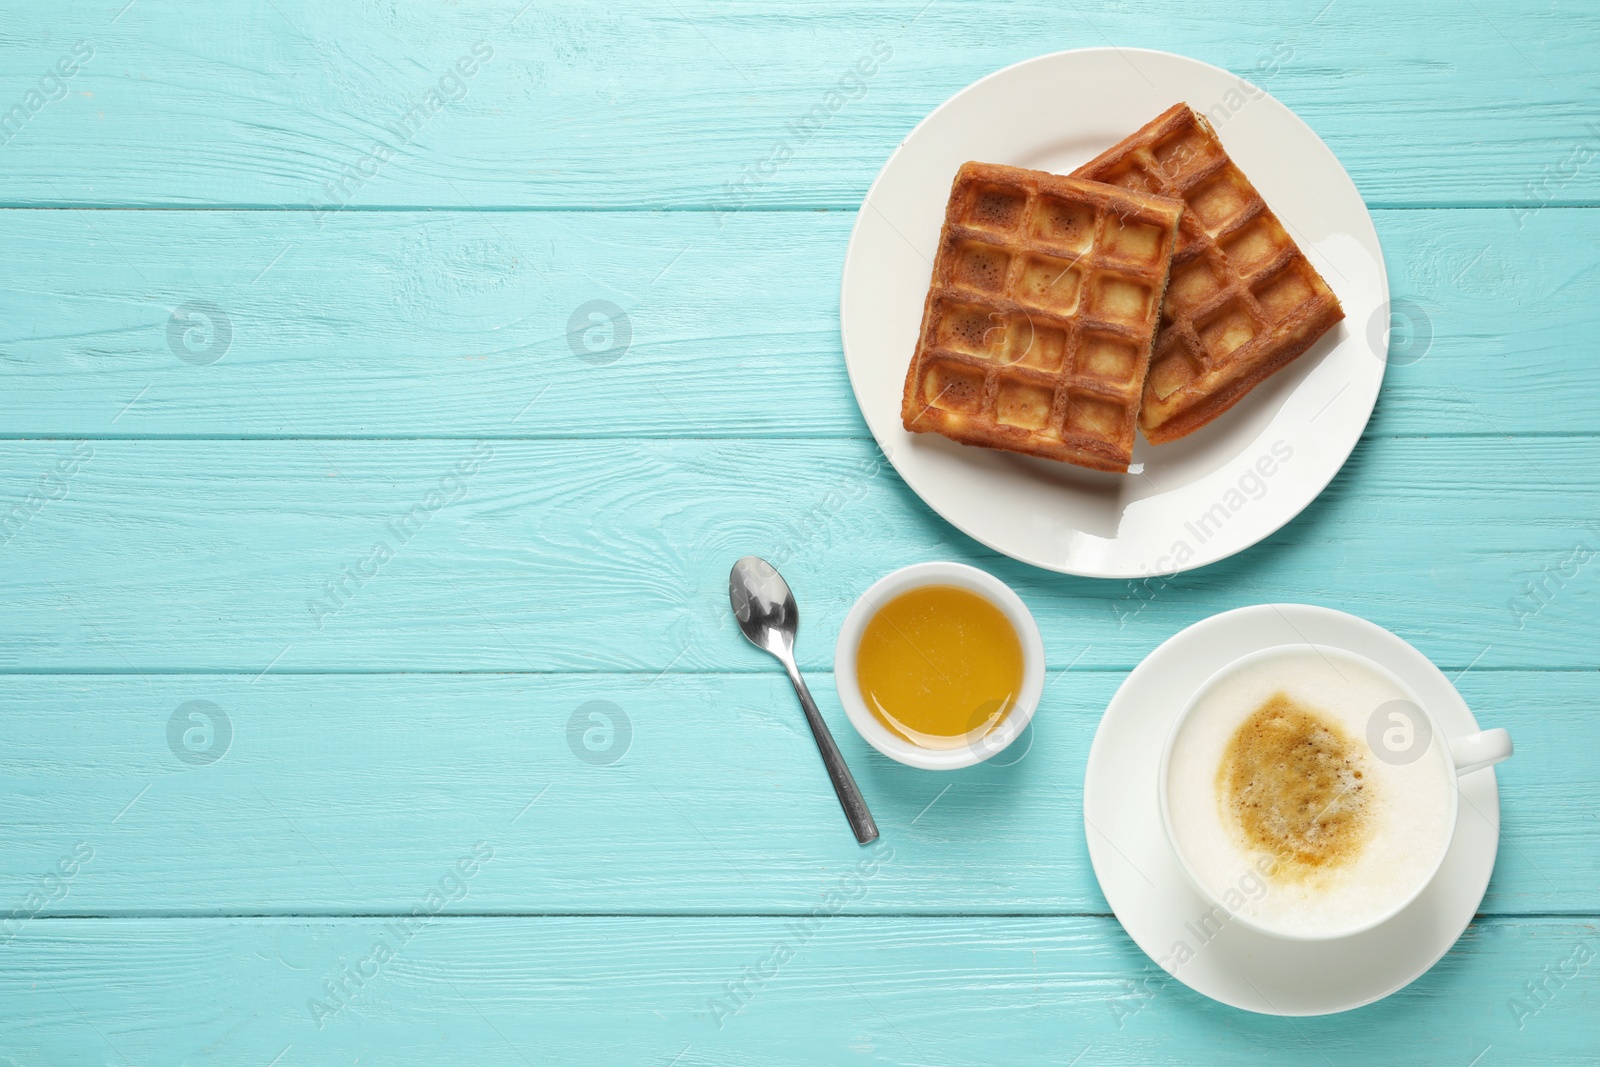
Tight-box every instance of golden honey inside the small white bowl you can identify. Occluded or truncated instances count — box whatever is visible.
[856,585,1022,749]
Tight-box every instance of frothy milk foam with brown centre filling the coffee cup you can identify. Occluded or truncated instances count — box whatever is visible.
[1166,648,1454,936]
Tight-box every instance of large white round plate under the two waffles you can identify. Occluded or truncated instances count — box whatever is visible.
[840,48,1389,577]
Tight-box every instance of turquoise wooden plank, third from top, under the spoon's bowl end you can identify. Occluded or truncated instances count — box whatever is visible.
[0,437,1600,675]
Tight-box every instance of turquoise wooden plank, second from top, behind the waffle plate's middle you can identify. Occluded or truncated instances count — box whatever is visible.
[0,206,1600,437]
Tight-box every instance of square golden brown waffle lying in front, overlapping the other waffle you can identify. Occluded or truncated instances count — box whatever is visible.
[901,163,1182,472]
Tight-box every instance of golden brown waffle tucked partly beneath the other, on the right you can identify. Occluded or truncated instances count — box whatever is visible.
[1072,104,1344,445]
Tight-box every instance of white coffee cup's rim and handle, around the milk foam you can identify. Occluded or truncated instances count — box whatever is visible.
[1157,645,1512,941]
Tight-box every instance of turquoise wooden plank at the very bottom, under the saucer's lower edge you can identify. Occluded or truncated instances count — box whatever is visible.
[0,915,1600,1067]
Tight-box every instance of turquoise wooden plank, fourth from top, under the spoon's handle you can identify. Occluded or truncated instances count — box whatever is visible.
[0,670,1580,917]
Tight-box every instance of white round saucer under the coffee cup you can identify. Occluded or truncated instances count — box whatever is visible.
[1083,605,1499,1016]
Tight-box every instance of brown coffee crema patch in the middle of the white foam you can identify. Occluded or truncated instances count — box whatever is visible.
[1216,693,1371,881]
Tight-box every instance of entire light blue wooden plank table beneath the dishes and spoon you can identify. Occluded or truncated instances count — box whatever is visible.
[0,0,1600,1067]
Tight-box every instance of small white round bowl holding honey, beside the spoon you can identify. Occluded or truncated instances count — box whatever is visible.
[834,563,1045,771]
